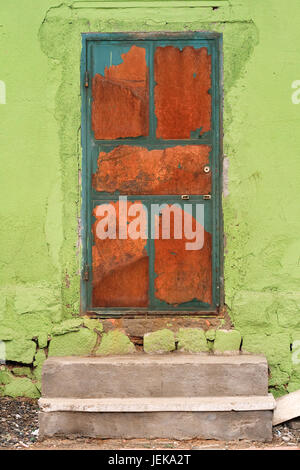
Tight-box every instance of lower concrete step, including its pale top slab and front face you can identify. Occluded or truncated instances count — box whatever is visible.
[39,395,275,441]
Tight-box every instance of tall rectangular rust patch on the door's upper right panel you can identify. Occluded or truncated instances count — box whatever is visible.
[154,46,211,139]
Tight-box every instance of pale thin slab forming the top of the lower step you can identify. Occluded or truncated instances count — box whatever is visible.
[39,394,276,413]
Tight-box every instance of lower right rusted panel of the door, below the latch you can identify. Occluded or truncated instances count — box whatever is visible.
[154,198,212,309]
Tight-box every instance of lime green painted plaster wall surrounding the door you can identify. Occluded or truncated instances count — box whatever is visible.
[0,0,300,396]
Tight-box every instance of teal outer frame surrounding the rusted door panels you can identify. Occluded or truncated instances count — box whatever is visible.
[80,32,224,317]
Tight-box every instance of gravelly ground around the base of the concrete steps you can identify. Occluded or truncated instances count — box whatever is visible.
[0,398,300,450]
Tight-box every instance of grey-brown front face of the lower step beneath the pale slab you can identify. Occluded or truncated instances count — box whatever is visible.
[39,411,272,441]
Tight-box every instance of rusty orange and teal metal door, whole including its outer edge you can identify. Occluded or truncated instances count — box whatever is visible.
[82,33,221,315]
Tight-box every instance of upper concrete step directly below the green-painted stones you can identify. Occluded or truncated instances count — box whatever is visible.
[42,353,268,398]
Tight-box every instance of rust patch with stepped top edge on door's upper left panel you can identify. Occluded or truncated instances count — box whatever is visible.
[92,46,149,139]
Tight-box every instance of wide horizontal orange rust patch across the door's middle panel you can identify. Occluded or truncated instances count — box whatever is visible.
[93,145,211,195]
